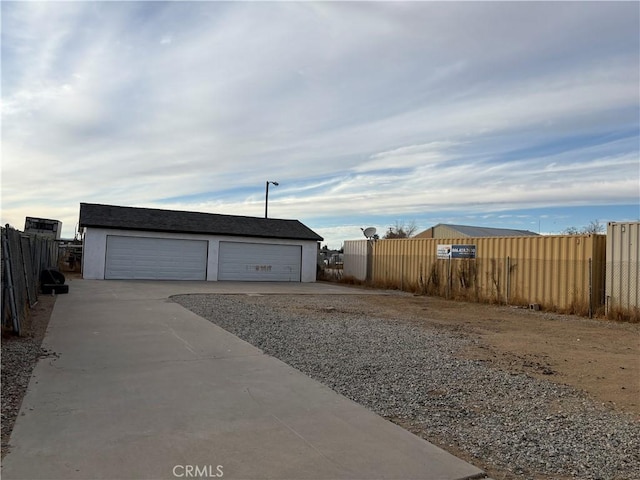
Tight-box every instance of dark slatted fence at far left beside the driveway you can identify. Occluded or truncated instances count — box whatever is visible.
[0,225,58,335]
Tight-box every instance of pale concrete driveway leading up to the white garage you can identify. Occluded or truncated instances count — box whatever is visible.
[2,280,482,480]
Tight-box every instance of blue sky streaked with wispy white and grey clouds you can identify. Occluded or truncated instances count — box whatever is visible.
[1,1,640,248]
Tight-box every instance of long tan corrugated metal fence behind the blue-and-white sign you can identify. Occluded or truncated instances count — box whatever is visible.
[345,235,606,315]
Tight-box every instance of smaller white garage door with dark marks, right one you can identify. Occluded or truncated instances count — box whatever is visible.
[218,242,302,282]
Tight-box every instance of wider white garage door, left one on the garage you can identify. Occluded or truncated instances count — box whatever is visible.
[104,235,208,280]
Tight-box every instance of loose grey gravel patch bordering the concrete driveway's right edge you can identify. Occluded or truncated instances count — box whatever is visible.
[173,295,640,480]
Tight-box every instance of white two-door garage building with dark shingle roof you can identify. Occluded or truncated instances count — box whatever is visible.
[79,203,322,282]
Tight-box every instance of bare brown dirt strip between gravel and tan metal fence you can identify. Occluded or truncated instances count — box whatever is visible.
[368,295,640,419]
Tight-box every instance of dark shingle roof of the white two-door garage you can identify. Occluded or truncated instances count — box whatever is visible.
[80,203,323,241]
